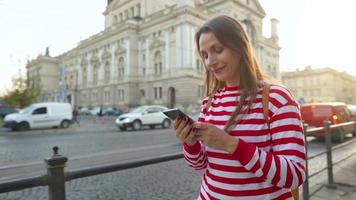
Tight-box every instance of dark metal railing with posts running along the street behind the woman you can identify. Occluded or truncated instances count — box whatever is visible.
[0,121,356,200]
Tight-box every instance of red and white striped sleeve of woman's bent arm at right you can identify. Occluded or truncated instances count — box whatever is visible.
[233,87,306,189]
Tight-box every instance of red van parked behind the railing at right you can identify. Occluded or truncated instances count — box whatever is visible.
[300,102,353,142]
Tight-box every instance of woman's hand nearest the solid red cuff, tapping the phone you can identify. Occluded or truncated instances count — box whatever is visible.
[193,122,239,153]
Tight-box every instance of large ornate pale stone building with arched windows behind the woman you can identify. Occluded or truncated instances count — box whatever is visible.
[27,0,280,110]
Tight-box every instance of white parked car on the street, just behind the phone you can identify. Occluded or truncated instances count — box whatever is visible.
[115,105,171,130]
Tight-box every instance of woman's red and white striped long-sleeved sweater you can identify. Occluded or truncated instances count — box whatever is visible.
[183,85,305,200]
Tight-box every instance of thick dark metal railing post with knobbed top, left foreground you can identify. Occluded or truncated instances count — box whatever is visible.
[45,146,68,200]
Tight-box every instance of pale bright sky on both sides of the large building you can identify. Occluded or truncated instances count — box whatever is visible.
[0,0,356,95]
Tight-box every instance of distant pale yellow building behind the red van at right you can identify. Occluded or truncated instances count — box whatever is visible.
[282,66,356,104]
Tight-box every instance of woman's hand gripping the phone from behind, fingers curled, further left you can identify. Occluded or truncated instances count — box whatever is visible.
[173,117,198,146]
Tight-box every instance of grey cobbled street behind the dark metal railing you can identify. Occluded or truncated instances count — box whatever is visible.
[0,117,355,200]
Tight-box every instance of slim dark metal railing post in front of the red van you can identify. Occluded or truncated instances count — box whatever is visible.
[324,121,336,189]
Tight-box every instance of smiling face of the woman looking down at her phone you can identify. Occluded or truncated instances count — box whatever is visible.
[199,32,240,86]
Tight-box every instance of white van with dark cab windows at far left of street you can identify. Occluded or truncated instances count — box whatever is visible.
[4,102,72,131]
